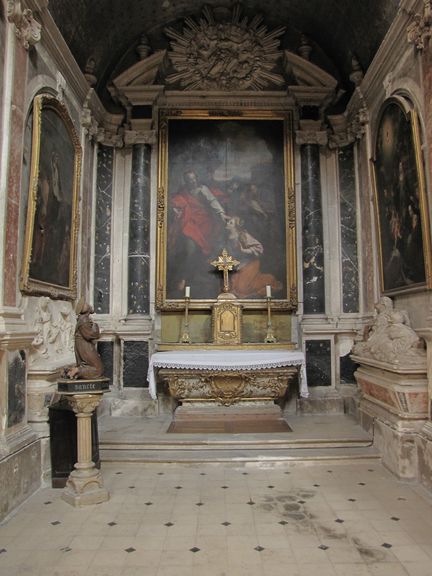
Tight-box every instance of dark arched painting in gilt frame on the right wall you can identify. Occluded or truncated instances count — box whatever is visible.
[372,97,431,295]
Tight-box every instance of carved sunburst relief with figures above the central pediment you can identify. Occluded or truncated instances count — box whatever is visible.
[165,5,285,90]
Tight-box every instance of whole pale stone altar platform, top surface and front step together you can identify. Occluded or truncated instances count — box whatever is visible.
[99,415,380,464]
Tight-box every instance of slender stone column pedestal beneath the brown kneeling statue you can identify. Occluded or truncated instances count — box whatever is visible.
[62,379,109,507]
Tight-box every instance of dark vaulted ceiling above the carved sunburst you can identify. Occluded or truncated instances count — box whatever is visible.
[48,0,399,108]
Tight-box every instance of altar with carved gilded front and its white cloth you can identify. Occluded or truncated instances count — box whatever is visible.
[147,348,308,406]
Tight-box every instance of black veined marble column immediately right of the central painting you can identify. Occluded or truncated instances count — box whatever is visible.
[301,144,325,314]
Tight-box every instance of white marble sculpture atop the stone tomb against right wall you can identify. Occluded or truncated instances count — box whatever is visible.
[353,296,426,366]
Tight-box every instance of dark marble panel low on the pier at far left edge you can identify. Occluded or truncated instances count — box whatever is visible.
[8,350,26,428]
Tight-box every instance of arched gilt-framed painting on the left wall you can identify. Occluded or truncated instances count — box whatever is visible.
[20,95,81,300]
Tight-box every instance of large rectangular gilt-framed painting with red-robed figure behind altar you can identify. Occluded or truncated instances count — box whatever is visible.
[156,110,297,309]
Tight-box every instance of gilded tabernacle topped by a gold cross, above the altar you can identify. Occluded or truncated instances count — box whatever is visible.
[211,248,242,344]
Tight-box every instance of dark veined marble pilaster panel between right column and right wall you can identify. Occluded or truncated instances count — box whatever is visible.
[338,146,359,313]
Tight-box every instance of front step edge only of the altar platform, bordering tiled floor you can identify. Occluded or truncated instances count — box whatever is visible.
[100,446,381,465]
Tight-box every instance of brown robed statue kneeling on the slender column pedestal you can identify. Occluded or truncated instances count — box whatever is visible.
[63,299,104,380]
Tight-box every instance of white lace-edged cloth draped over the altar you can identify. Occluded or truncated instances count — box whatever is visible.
[147,349,309,400]
